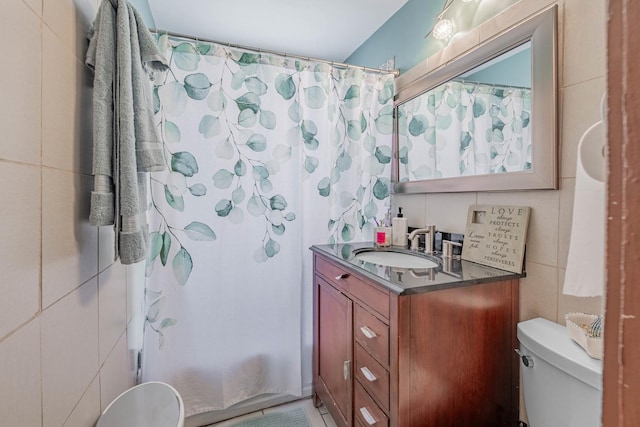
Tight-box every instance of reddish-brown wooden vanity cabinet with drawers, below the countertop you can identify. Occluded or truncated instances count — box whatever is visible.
[313,253,519,427]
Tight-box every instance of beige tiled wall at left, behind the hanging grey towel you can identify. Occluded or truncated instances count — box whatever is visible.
[0,0,136,427]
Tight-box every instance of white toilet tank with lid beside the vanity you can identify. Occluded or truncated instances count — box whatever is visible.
[518,318,602,427]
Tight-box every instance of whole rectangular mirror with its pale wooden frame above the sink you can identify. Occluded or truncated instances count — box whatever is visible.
[393,6,558,193]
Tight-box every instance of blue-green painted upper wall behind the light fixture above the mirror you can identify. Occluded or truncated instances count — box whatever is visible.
[344,0,519,73]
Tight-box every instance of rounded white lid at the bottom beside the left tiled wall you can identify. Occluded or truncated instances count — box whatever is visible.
[95,382,184,427]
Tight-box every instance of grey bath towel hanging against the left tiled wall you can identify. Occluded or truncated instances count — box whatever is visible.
[85,0,168,264]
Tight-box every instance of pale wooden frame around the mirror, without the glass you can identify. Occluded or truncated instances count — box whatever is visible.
[392,5,558,193]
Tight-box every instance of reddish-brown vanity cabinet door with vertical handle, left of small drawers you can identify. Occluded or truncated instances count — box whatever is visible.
[316,278,353,426]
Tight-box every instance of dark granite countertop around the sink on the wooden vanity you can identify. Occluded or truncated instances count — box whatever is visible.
[310,242,525,295]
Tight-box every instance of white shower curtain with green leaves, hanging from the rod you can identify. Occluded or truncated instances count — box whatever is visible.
[143,35,394,416]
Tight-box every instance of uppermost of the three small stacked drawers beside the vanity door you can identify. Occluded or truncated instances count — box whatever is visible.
[354,305,389,366]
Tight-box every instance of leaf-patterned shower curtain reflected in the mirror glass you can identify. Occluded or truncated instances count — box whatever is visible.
[398,81,531,181]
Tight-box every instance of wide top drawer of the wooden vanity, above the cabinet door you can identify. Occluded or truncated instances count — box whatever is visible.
[316,257,389,319]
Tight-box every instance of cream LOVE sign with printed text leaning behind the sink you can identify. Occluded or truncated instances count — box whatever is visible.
[462,205,531,273]
